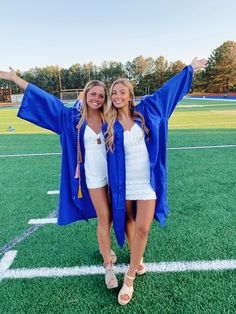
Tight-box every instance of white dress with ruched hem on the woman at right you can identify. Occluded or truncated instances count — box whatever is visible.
[124,123,156,200]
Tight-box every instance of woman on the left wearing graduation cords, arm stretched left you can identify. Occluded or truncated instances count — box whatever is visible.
[0,68,118,289]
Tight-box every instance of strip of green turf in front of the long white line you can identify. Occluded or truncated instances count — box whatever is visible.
[0,271,236,314]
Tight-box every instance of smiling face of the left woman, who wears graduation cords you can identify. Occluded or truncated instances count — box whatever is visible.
[86,86,105,110]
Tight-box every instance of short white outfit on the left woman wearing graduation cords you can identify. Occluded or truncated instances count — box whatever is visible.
[84,125,108,189]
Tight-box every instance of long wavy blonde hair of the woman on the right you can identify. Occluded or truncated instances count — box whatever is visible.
[105,78,149,151]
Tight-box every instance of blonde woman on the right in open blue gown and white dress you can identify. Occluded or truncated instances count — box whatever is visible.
[106,58,206,305]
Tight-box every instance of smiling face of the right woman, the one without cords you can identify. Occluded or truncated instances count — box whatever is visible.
[111,83,132,109]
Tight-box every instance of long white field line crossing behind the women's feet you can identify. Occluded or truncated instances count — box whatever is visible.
[3,260,236,279]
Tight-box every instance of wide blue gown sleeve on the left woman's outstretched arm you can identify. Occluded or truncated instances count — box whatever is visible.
[17,83,69,134]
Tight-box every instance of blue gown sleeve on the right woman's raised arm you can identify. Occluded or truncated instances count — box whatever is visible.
[142,65,193,120]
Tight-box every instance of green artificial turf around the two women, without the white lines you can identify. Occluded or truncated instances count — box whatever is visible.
[0,101,236,314]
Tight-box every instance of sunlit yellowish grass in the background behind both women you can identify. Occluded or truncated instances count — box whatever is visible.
[0,99,236,134]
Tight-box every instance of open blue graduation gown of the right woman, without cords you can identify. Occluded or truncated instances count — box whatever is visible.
[104,65,193,246]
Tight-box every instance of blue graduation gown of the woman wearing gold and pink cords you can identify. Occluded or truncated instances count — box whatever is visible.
[17,83,96,225]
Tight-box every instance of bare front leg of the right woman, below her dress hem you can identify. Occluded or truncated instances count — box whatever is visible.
[121,200,156,301]
